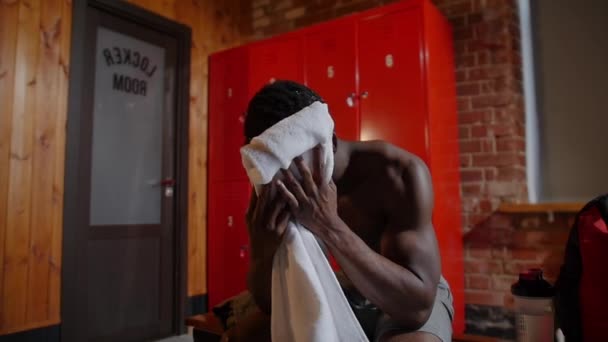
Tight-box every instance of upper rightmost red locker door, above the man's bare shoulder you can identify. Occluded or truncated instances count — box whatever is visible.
[358,7,428,162]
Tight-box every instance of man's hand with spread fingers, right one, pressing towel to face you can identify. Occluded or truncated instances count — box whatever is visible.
[277,146,344,240]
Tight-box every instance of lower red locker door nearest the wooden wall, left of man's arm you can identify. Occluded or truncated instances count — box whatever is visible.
[207,181,250,308]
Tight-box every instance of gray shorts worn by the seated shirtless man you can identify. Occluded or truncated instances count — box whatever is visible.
[345,277,454,342]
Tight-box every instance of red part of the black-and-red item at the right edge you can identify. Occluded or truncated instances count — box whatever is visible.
[578,206,608,341]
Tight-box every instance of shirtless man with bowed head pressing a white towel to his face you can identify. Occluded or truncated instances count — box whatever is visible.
[237,81,453,342]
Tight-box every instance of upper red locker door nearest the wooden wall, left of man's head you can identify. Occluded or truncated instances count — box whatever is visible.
[209,47,248,181]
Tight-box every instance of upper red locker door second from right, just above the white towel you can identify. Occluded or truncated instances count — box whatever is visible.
[304,20,359,140]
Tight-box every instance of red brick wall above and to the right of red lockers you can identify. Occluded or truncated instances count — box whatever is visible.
[245,0,572,338]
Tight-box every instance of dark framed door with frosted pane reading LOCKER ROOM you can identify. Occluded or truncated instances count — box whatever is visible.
[62,5,189,341]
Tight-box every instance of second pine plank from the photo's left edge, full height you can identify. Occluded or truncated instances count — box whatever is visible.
[4,1,40,332]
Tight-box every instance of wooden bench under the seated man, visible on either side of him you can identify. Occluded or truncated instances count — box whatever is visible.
[186,313,499,342]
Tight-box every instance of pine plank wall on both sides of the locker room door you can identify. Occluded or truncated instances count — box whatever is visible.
[0,0,248,335]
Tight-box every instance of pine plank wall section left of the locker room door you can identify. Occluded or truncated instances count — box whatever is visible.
[0,0,71,335]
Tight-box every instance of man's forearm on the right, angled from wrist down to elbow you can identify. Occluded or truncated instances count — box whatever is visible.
[325,220,436,329]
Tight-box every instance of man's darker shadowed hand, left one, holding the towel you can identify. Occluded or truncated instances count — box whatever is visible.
[246,181,290,261]
